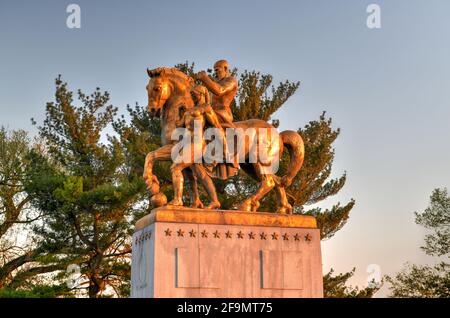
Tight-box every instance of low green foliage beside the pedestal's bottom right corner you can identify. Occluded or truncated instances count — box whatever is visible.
[323,268,381,298]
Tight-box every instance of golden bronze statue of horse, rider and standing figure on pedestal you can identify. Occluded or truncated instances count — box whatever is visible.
[144,60,304,213]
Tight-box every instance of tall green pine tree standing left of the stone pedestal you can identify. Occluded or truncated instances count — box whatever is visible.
[26,77,145,297]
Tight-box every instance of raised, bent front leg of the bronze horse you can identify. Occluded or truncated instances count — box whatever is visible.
[143,144,173,206]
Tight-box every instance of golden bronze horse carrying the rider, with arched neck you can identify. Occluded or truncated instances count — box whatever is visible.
[144,68,304,214]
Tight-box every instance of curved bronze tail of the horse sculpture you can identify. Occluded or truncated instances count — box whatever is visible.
[280,130,305,187]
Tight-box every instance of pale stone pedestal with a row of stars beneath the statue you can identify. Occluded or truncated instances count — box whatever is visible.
[131,207,323,298]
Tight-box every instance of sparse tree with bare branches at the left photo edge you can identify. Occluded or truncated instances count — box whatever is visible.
[0,127,54,288]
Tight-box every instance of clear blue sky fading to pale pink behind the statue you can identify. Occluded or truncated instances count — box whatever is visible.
[0,0,450,295]
